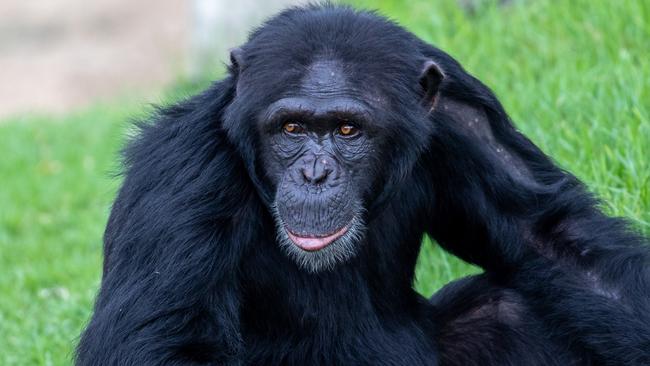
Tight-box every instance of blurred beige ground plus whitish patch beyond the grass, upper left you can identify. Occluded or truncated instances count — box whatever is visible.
[0,0,308,118]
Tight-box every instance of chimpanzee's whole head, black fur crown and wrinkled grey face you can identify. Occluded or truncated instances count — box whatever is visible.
[220,7,443,271]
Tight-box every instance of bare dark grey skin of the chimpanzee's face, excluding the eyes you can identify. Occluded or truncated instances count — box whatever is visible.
[261,61,373,272]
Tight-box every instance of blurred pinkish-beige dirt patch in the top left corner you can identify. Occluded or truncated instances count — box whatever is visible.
[0,0,190,118]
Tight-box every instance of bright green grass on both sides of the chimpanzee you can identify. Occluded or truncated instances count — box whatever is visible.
[0,0,650,365]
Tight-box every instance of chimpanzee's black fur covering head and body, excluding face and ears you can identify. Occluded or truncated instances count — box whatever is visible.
[76,6,650,365]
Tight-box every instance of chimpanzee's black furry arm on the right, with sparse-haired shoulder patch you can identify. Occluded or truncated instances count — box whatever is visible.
[420,49,650,365]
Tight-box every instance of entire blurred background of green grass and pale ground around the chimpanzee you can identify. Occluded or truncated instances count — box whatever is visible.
[0,0,650,365]
